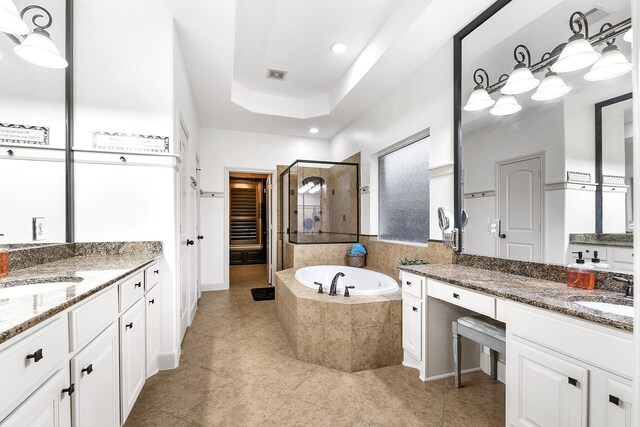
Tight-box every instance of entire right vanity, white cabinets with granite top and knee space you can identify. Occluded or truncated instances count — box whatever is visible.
[399,264,636,427]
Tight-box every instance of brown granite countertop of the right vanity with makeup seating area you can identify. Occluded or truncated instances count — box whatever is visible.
[398,264,633,332]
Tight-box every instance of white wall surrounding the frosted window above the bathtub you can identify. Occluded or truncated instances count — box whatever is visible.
[331,41,453,239]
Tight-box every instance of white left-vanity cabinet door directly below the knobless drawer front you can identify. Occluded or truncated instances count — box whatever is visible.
[71,323,120,427]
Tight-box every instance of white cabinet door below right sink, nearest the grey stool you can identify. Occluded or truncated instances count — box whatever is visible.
[507,341,589,427]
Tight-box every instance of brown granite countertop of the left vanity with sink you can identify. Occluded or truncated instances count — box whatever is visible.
[0,253,161,344]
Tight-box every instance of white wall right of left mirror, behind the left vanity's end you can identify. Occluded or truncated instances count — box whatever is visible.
[74,0,199,369]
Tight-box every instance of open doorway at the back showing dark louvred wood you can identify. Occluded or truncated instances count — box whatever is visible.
[228,172,270,266]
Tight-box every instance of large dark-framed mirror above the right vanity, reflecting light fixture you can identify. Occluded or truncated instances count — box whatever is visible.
[456,0,634,272]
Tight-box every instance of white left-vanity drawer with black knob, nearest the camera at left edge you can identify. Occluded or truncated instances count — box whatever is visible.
[0,316,69,419]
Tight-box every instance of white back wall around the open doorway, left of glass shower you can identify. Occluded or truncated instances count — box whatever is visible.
[200,128,330,290]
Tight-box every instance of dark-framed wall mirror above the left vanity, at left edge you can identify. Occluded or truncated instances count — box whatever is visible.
[0,0,72,246]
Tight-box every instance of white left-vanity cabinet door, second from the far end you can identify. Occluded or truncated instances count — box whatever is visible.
[120,300,146,424]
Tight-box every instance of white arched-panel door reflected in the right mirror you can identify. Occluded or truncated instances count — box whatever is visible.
[498,157,542,262]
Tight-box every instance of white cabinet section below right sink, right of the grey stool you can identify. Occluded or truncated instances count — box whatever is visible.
[507,302,635,427]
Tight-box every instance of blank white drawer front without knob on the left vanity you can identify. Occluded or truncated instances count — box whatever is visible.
[69,286,118,351]
